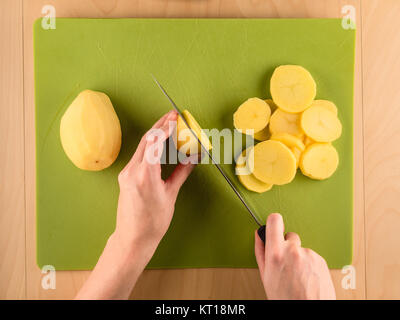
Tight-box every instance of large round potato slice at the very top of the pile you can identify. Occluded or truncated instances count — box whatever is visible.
[270,65,317,113]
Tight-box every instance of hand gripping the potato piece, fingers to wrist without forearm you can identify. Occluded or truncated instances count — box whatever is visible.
[115,111,194,255]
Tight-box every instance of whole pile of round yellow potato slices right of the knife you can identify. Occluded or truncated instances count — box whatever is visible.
[233,65,342,193]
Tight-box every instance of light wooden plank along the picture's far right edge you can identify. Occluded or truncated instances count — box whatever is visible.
[362,0,400,299]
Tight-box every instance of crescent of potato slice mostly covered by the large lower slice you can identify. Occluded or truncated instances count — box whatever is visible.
[235,146,272,193]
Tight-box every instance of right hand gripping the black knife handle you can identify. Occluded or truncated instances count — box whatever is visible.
[255,213,336,300]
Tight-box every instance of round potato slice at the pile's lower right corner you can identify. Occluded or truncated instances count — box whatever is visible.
[300,143,339,180]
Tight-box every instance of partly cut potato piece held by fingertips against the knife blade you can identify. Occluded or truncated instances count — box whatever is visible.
[175,110,212,155]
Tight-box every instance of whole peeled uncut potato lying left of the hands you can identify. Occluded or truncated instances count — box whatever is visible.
[60,90,121,171]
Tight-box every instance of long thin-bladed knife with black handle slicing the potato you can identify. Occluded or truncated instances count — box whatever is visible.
[151,75,265,244]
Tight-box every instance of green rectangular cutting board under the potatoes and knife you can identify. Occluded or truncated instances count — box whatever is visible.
[34,19,355,270]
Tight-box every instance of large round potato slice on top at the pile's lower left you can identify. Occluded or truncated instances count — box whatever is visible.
[248,140,296,185]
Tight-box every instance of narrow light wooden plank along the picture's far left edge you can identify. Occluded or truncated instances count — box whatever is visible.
[0,0,25,299]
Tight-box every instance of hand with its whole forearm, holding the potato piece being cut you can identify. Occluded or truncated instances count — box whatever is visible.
[76,111,194,299]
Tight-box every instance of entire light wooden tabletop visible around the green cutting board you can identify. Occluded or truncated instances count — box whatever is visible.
[0,0,400,299]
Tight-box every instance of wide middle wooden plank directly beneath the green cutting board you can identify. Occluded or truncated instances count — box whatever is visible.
[24,0,365,299]
